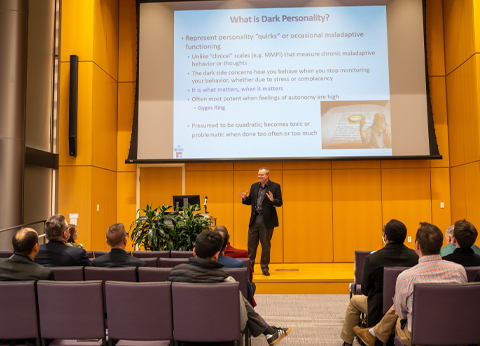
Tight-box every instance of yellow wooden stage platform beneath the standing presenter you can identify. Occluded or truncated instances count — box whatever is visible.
[253,263,353,294]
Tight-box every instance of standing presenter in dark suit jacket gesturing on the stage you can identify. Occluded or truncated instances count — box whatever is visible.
[238,167,283,276]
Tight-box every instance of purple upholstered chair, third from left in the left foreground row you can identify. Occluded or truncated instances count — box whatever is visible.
[105,282,173,346]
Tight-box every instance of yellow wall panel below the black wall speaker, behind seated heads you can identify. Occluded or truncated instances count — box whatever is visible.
[58,166,92,250]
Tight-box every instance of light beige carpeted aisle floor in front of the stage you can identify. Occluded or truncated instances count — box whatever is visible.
[252,294,358,346]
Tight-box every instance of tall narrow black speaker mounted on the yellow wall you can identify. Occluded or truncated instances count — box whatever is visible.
[68,55,78,156]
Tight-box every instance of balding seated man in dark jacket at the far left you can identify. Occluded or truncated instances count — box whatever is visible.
[0,228,55,281]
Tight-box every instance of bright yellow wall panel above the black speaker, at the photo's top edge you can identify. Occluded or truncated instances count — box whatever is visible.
[60,0,96,61]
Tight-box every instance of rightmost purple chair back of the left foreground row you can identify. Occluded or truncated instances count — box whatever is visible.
[172,282,242,343]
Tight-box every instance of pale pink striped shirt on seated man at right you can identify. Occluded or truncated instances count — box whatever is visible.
[394,255,467,332]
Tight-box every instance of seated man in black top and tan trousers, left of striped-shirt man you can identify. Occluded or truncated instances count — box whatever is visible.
[340,219,418,345]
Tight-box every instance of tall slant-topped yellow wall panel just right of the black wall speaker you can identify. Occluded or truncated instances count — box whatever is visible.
[92,65,117,171]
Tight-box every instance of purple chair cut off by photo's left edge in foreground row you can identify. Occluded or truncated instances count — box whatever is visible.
[0,281,40,345]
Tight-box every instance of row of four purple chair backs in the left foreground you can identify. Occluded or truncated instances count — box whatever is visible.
[0,281,249,346]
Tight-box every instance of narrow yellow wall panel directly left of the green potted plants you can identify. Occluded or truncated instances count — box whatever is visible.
[117,172,137,251]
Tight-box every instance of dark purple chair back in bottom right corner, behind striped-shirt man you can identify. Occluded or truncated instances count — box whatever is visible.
[412,282,480,345]
